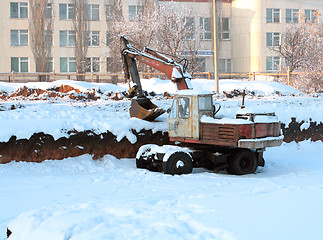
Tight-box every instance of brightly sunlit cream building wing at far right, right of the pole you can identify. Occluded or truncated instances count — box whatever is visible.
[230,0,323,72]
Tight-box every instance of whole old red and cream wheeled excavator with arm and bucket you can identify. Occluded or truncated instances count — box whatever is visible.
[121,36,284,175]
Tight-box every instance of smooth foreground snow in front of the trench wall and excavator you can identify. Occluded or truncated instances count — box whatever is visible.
[0,141,323,240]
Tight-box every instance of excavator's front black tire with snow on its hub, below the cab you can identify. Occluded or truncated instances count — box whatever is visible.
[163,152,193,175]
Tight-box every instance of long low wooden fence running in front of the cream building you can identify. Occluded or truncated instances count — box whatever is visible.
[0,71,323,85]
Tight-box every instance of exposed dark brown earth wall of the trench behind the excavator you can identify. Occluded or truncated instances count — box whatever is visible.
[0,118,323,163]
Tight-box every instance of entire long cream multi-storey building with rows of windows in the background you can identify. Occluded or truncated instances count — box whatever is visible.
[0,0,323,73]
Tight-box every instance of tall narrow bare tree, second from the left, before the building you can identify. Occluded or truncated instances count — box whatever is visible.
[71,0,89,80]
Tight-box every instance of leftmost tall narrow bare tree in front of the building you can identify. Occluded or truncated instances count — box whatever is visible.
[29,0,53,81]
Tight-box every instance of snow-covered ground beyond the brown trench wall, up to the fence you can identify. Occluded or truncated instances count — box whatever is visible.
[0,79,323,142]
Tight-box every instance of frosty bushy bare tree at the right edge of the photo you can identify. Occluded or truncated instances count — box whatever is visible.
[272,10,323,91]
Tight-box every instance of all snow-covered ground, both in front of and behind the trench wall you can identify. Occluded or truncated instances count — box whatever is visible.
[0,79,323,240]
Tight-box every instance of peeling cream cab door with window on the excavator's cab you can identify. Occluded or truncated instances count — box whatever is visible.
[167,96,192,138]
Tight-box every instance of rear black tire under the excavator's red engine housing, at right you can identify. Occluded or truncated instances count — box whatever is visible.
[228,149,258,175]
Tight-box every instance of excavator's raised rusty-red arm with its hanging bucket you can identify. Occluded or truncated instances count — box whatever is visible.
[120,36,192,121]
